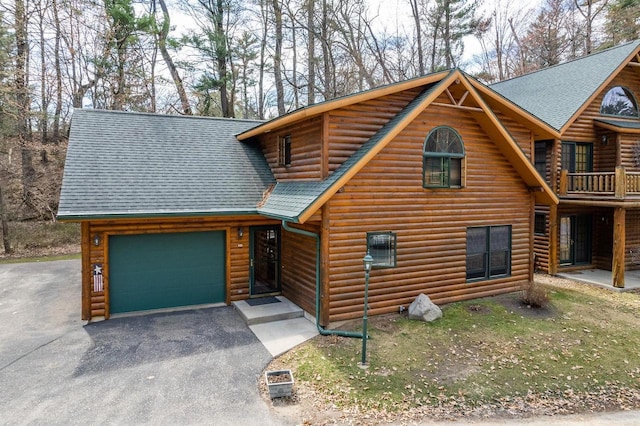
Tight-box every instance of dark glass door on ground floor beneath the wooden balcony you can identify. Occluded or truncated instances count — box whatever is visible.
[560,215,591,265]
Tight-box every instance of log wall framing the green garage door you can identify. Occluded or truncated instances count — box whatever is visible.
[82,216,279,320]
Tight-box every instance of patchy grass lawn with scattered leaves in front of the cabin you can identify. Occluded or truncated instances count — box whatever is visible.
[269,279,640,420]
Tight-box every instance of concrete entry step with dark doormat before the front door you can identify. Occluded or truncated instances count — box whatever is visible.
[232,296,304,325]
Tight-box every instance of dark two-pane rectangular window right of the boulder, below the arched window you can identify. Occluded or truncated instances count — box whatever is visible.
[467,225,511,281]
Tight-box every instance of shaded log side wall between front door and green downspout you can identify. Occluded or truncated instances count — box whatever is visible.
[282,225,320,314]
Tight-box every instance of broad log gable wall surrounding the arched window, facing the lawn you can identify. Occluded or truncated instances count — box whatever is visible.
[329,106,533,321]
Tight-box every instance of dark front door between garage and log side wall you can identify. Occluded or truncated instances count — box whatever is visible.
[250,226,280,296]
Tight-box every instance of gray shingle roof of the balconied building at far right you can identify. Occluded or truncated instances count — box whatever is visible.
[490,40,640,132]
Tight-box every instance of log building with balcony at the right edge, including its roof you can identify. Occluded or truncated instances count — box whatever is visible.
[491,41,640,287]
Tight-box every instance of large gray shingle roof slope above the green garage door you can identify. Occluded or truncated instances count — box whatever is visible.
[58,109,275,220]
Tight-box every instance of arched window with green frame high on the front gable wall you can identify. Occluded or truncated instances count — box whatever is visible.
[422,126,464,188]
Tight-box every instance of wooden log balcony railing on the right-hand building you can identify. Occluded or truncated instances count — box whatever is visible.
[558,167,640,199]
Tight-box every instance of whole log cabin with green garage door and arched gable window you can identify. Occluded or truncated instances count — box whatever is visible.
[58,70,558,326]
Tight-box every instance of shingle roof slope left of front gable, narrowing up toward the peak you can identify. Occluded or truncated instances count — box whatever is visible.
[258,84,437,221]
